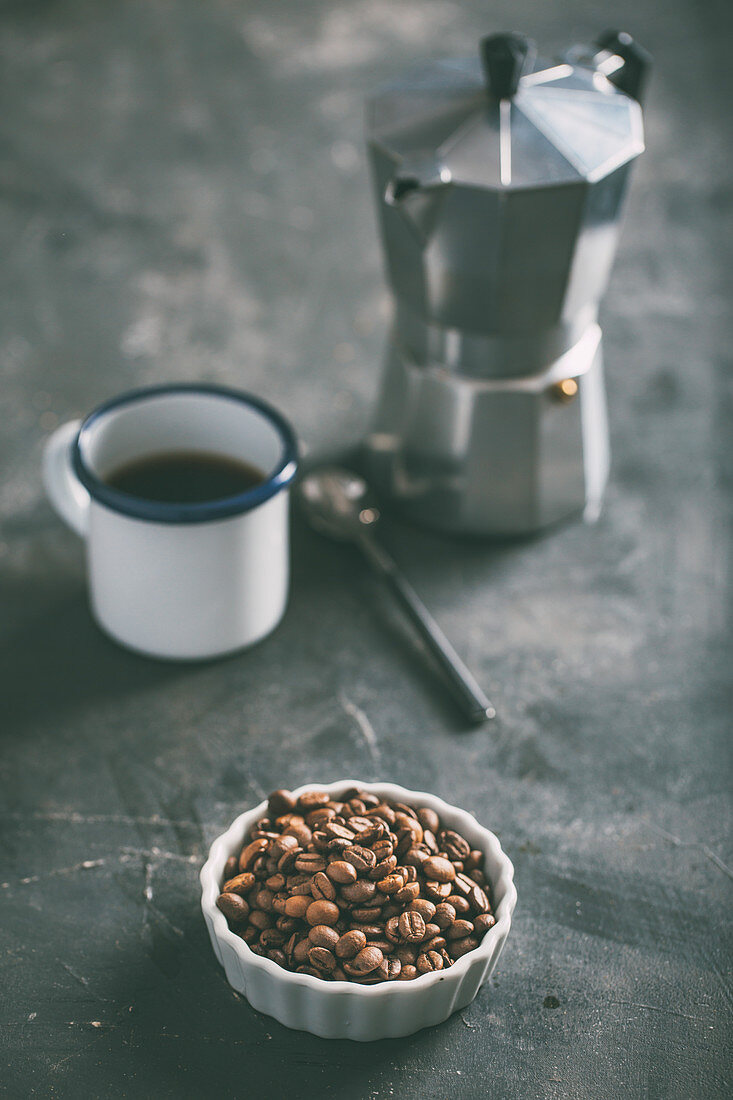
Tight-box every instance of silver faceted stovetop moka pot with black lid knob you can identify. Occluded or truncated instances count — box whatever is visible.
[365,32,649,535]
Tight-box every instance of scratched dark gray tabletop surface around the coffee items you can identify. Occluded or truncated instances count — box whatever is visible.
[0,0,733,1100]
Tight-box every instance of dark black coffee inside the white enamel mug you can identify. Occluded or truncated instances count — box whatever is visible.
[105,451,265,504]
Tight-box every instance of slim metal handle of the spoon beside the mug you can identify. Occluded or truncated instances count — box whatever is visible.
[358,531,496,725]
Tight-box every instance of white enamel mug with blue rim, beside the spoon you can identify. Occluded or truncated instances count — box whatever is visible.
[43,384,297,660]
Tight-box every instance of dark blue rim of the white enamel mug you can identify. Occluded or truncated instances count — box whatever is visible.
[72,383,298,524]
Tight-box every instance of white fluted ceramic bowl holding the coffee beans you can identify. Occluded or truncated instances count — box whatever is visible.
[201,779,516,1042]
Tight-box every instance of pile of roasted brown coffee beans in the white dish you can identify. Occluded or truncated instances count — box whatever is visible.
[217,789,494,985]
